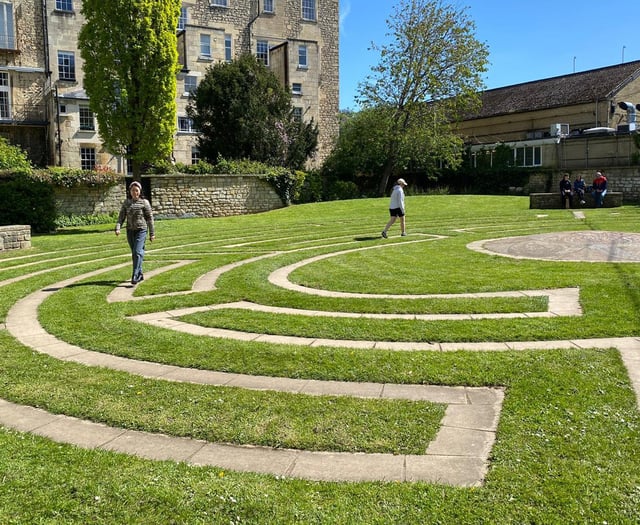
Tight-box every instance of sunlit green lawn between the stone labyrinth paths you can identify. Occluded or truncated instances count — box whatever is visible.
[0,196,640,524]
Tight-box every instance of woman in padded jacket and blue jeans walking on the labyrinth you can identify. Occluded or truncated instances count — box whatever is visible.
[116,181,155,285]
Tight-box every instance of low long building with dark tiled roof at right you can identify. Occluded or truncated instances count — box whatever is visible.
[458,61,640,169]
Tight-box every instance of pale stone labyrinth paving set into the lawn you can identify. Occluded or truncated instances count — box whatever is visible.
[0,232,640,486]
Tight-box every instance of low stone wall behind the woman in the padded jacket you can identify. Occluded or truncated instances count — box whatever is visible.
[56,174,284,218]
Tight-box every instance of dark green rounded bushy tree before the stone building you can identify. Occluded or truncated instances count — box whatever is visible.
[188,54,318,169]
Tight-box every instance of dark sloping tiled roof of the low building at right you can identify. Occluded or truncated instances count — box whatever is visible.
[468,60,640,119]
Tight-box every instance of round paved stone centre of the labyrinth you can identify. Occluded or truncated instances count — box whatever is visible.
[467,231,640,263]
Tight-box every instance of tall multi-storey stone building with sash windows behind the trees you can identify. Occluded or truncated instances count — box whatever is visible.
[0,0,339,173]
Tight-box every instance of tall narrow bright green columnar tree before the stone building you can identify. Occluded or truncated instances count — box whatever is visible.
[79,0,181,179]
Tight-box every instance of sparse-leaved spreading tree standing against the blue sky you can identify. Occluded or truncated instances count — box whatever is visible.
[358,0,489,194]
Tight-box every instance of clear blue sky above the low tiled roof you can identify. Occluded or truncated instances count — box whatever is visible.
[340,0,640,109]
